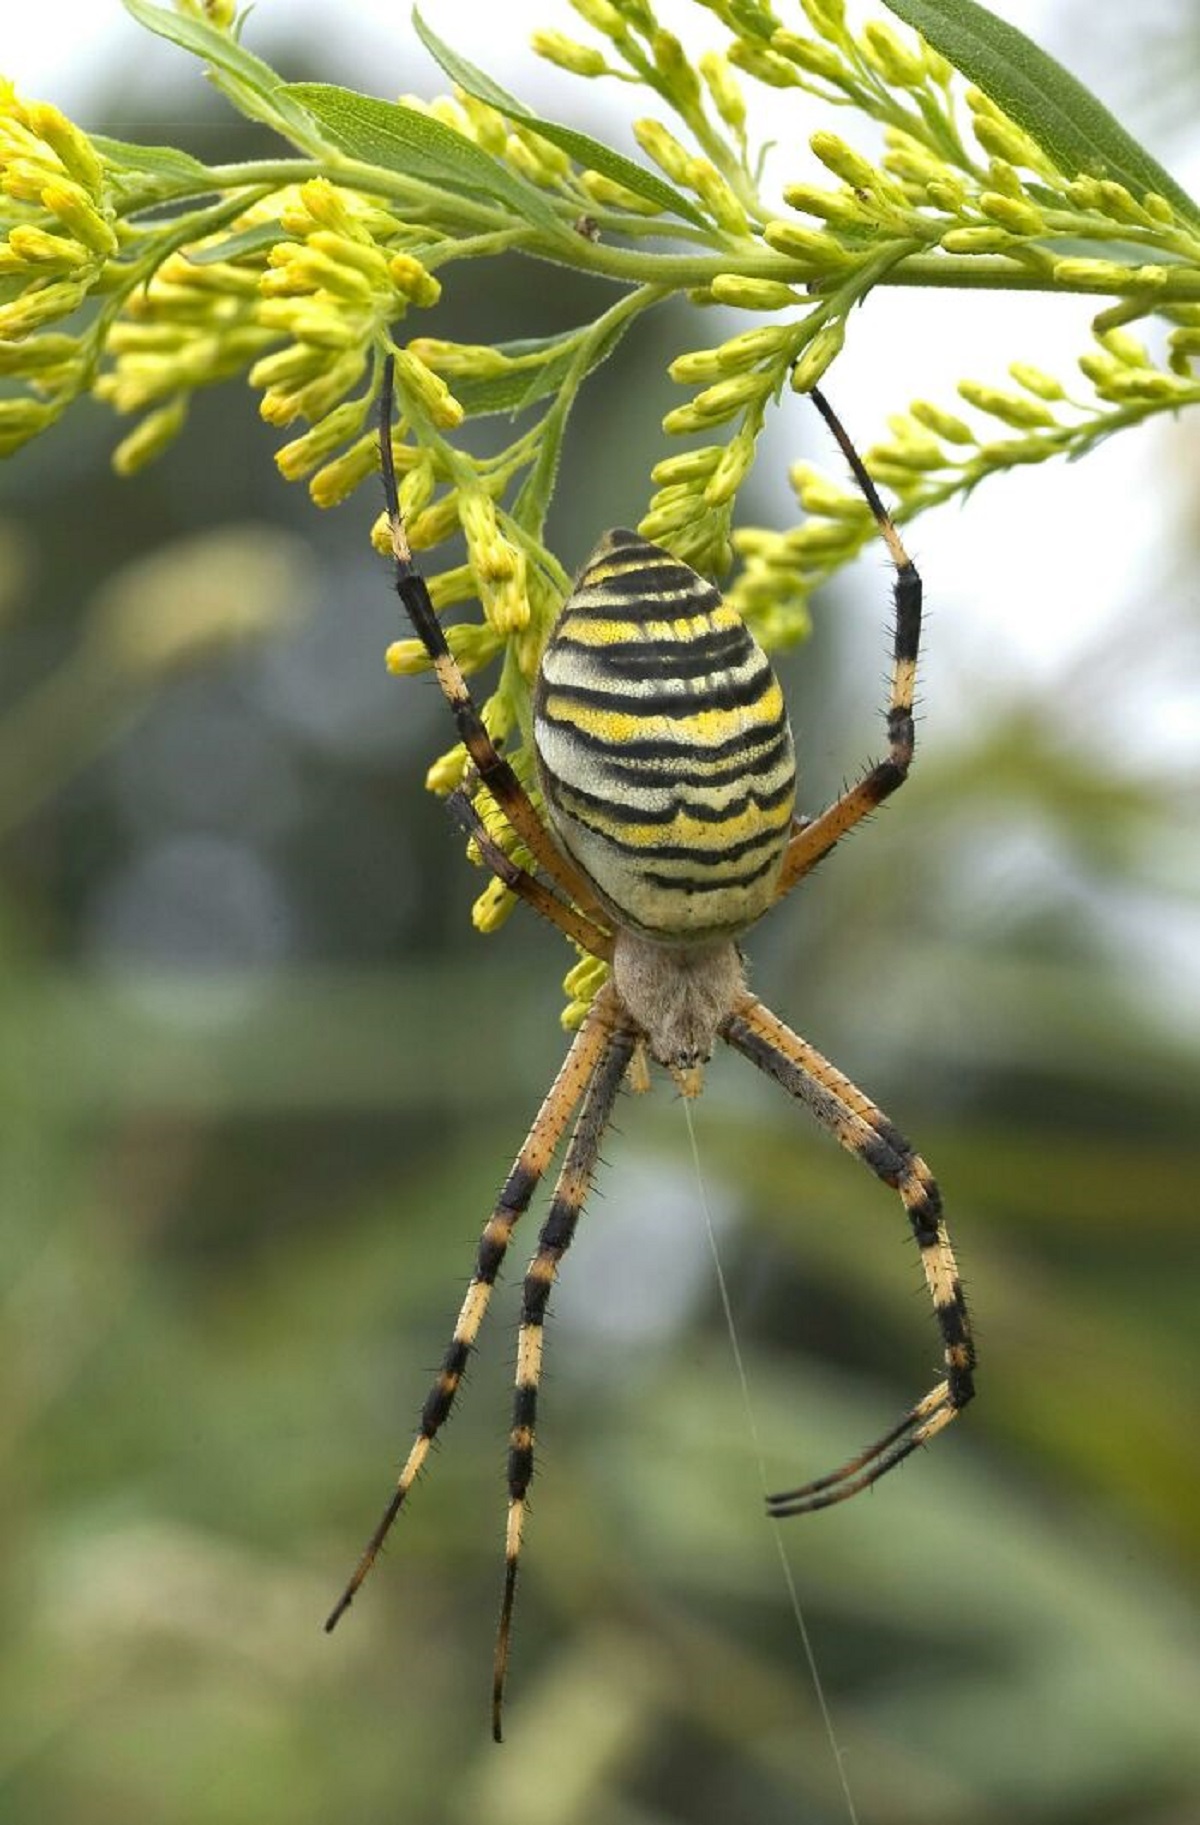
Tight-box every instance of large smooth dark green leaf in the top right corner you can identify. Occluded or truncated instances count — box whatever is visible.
[886,0,1200,226]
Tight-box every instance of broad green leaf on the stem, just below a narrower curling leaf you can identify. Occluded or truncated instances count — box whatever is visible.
[283,82,565,237]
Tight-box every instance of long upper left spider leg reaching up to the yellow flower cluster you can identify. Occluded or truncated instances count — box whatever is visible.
[379,356,598,927]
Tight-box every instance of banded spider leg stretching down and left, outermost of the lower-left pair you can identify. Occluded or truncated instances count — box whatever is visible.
[325,989,611,1632]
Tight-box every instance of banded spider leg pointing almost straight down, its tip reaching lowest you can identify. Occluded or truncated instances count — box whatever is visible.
[492,1026,636,1743]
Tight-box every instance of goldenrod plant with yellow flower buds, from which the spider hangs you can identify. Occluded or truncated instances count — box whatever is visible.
[0,0,1200,1013]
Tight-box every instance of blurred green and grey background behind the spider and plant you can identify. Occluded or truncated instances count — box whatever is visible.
[0,7,1200,1825]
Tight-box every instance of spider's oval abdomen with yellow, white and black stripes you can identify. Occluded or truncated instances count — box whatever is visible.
[534,531,795,942]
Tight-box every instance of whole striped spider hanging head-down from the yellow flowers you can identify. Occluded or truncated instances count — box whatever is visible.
[325,361,976,1741]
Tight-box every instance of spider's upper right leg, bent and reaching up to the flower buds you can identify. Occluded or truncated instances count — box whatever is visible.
[775,387,921,900]
